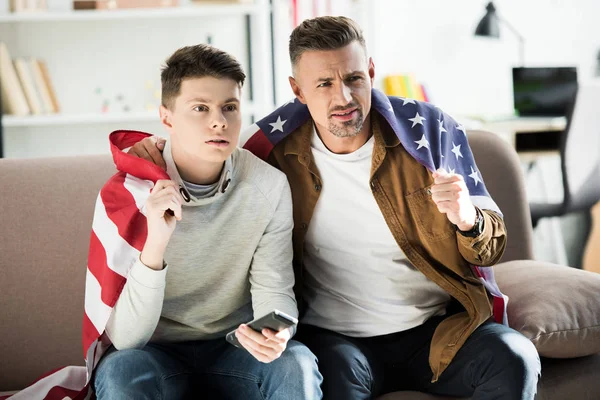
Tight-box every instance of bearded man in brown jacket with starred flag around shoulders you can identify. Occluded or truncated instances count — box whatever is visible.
[132,17,540,399]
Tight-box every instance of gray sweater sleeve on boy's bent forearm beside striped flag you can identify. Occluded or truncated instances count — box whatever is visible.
[106,259,167,350]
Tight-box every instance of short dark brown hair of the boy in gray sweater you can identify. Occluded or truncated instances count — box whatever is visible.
[160,44,246,108]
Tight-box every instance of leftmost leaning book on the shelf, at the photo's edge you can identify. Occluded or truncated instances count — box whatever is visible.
[0,42,30,116]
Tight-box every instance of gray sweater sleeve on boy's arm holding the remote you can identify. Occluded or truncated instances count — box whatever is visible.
[250,176,298,317]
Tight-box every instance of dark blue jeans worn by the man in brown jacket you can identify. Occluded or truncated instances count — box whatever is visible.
[296,317,541,400]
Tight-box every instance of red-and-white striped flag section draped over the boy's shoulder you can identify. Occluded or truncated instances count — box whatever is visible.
[0,131,169,400]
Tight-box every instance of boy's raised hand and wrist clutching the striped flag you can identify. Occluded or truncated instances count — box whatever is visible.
[140,180,183,270]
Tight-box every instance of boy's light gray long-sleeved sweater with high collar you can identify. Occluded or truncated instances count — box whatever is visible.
[106,141,298,349]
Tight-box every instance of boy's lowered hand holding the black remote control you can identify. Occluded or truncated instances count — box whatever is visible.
[235,324,292,363]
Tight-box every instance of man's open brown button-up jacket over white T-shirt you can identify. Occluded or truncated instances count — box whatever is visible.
[268,110,506,382]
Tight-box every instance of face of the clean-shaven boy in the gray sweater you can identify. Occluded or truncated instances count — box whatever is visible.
[160,76,242,163]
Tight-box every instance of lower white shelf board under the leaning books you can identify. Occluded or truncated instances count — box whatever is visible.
[2,104,257,128]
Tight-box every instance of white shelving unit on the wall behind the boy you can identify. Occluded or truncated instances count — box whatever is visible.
[0,0,275,157]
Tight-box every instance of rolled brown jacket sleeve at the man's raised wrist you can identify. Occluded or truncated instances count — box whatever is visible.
[456,209,506,267]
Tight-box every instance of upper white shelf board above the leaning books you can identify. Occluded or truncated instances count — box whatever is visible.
[0,4,263,23]
